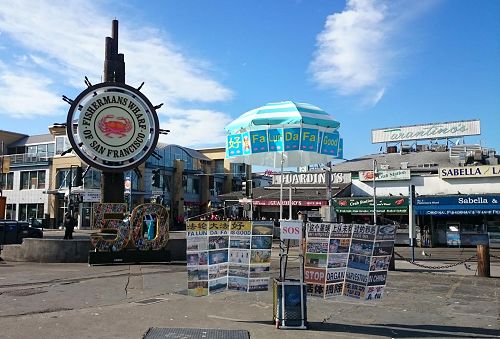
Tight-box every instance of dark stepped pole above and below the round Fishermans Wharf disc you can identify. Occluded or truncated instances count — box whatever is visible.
[101,20,125,203]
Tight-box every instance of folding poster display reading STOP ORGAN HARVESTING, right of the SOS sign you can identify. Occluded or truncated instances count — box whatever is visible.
[304,223,396,300]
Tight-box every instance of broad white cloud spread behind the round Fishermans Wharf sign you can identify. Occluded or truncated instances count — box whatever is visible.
[0,0,233,145]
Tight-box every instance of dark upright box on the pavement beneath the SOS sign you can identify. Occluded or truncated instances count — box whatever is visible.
[273,279,307,329]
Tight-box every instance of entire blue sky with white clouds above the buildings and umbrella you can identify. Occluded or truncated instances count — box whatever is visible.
[0,0,500,158]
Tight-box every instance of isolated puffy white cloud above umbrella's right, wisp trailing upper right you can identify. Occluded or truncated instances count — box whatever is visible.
[310,0,431,105]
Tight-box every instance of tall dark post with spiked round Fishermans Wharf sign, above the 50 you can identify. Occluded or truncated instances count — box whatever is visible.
[63,20,160,203]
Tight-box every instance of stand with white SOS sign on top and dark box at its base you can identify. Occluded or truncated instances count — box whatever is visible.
[273,220,307,329]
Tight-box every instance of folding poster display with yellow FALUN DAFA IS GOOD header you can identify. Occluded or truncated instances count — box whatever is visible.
[186,221,273,297]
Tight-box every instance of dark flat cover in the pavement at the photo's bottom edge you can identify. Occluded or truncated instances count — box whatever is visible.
[144,327,250,339]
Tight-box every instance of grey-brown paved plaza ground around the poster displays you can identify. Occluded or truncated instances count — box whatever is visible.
[0,247,500,339]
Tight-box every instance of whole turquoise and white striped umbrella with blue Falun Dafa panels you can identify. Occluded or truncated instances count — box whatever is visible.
[225,101,343,168]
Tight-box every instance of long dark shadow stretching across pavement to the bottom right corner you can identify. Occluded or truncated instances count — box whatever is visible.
[235,321,500,338]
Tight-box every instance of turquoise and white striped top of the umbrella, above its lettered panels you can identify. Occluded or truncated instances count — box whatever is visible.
[225,101,340,134]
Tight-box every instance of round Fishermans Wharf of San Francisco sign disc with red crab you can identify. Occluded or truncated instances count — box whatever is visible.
[66,83,159,172]
